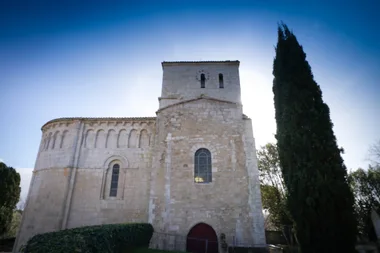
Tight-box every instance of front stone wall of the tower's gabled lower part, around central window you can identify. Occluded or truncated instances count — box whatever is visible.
[150,98,265,247]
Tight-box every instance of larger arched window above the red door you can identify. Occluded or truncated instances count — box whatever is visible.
[194,148,212,183]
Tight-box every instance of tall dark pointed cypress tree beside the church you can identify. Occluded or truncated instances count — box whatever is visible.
[273,24,357,253]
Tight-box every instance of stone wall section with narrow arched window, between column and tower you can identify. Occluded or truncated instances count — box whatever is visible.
[67,118,155,228]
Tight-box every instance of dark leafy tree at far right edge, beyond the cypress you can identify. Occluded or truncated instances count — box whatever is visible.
[348,166,380,241]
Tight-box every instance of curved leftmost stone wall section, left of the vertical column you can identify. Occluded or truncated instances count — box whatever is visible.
[15,120,80,249]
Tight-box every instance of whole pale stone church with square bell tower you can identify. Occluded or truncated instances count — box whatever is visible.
[14,61,266,252]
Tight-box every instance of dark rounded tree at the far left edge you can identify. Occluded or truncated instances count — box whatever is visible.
[0,162,21,235]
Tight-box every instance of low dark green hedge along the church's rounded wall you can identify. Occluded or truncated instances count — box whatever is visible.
[24,223,153,253]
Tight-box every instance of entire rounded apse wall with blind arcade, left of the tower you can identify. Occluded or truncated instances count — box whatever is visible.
[15,118,155,249]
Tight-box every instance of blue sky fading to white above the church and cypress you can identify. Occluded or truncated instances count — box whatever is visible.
[0,0,380,202]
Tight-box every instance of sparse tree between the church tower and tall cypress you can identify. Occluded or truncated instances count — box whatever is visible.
[257,143,292,231]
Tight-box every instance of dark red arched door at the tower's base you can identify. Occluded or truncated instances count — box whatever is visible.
[186,223,218,253]
